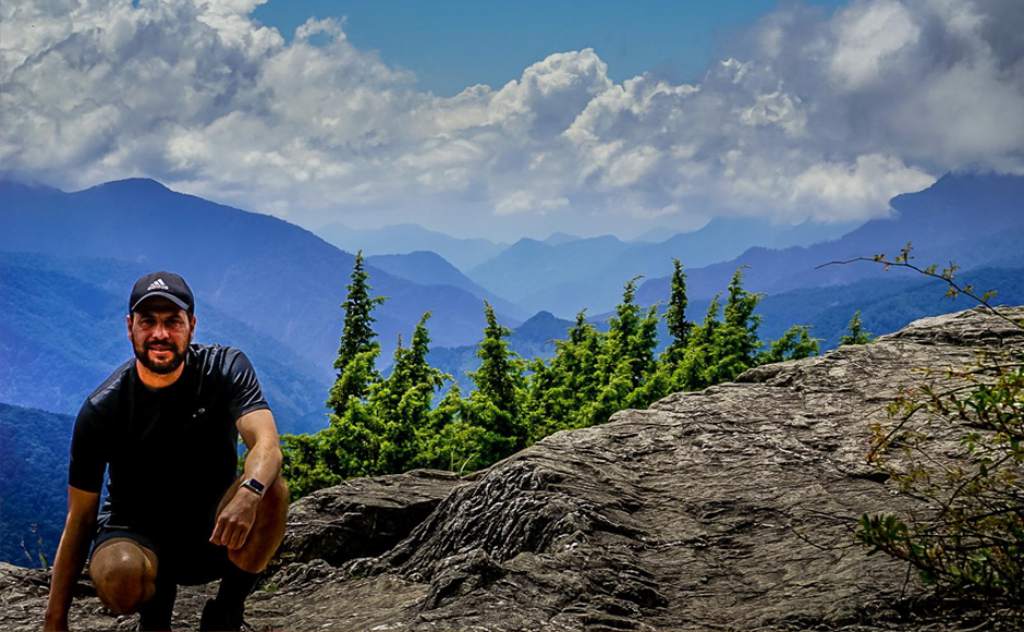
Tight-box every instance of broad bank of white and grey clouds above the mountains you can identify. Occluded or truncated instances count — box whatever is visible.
[0,0,1024,238]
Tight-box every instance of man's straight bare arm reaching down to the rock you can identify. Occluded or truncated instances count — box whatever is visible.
[43,486,99,631]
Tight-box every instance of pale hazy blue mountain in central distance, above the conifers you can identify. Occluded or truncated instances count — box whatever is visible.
[469,218,857,318]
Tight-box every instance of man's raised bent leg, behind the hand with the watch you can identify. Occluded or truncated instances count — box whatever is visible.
[200,476,289,630]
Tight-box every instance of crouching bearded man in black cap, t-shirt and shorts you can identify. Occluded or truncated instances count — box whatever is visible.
[44,271,288,630]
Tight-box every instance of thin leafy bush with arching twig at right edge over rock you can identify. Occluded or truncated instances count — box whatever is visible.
[818,244,1024,608]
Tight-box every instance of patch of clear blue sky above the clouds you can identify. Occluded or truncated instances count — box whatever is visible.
[253,0,844,96]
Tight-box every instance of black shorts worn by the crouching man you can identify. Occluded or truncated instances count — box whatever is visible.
[92,512,231,586]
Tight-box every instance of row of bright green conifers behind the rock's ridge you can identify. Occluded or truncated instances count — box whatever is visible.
[283,252,869,498]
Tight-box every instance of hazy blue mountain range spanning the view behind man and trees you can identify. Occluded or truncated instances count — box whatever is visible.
[0,174,1024,431]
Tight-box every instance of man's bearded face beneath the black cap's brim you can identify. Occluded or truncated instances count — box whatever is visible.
[128,297,196,374]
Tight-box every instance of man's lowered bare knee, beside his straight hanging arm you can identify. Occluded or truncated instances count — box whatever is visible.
[89,540,157,615]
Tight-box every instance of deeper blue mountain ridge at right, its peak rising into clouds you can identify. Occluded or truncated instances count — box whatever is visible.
[637,174,1024,304]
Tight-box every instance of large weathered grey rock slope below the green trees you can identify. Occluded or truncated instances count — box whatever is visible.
[0,309,1024,632]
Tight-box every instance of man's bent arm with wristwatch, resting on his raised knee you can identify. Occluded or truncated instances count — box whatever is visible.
[210,409,283,549]
